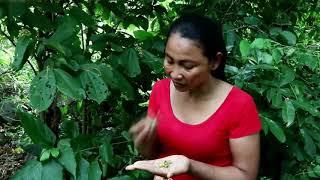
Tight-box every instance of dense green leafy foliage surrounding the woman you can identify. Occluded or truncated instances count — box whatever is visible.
[0,0,320,180]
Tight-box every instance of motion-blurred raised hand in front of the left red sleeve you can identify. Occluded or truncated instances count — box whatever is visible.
[129,116,157,157]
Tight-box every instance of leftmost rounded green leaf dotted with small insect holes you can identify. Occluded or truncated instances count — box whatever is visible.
[30,69,56,111]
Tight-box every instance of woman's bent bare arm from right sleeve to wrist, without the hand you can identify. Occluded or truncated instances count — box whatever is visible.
[189,134,260,180]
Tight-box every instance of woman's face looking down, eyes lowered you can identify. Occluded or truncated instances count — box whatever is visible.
[164,33,214,92]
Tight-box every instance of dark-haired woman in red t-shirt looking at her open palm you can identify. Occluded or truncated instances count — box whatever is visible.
[126,16,261,180]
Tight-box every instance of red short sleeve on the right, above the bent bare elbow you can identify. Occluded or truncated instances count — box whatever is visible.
[230,97,261,138]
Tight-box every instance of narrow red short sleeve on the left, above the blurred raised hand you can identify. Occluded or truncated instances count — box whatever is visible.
[148,82,160,117]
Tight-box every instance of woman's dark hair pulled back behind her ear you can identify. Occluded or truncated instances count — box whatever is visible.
[167,15,227,80]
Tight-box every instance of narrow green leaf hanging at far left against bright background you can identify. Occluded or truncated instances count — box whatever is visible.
[11,36,35,71]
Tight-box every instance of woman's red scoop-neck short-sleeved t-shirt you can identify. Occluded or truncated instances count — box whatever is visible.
[148,79,261,180]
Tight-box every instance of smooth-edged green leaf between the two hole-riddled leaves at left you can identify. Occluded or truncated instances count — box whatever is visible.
[54,69,86,100]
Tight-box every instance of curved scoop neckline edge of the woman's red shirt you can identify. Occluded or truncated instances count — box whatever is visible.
[168,79,235,127]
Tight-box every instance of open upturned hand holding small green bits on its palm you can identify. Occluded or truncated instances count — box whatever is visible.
[126,155,190,178]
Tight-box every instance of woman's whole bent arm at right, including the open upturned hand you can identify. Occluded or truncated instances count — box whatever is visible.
[126,134,260,180]
